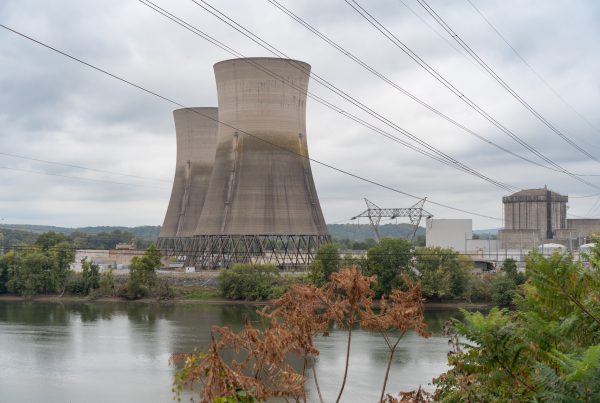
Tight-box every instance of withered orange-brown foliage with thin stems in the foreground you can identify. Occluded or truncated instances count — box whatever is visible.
[173,268,429,402]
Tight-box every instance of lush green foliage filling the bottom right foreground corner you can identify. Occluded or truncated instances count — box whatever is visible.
[436,246,600,402]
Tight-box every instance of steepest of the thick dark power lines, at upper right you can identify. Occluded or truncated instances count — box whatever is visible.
[417,0,600,162]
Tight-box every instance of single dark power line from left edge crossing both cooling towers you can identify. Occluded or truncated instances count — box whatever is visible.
[0,24,502,221]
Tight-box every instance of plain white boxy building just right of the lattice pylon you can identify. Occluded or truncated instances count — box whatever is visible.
[425,218,473,252]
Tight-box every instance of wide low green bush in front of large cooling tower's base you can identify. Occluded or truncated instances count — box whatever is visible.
[218,264,283,300]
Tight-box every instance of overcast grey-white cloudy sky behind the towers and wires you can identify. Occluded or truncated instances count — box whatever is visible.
[0,0,600,228]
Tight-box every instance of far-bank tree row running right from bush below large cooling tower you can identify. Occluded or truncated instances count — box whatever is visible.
[214,238,526,305]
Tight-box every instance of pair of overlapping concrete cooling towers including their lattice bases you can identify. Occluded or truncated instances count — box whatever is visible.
[158,58,331,268]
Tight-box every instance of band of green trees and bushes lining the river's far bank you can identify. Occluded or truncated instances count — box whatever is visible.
[0,233,526,307]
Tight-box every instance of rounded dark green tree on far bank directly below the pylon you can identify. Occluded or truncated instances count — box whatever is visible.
[364,238,412,297]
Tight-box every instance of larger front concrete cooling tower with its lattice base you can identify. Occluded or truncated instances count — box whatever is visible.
[189,58,330,268]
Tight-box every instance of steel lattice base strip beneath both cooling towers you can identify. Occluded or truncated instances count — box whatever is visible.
[157,235,331,269]
